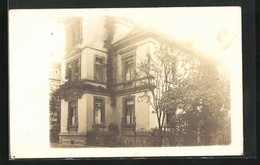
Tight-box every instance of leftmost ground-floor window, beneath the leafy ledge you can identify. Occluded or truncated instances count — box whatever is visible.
[68,100,78,126]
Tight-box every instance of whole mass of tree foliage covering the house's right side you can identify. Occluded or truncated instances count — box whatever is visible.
[137,44,230,145]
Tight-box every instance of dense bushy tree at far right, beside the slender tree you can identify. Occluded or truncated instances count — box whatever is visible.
[167,54,231,145]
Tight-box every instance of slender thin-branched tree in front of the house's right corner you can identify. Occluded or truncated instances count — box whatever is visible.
[136,44,178,146]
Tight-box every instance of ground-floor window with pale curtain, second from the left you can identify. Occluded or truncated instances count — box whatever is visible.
[94,97,105,125]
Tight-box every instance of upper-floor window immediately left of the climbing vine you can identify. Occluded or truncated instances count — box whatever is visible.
[95,57,105,82]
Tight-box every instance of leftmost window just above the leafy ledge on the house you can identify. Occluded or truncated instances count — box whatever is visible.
[66,59,80,81]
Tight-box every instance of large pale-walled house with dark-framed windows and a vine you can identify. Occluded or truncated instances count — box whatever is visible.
[60,17,201,145]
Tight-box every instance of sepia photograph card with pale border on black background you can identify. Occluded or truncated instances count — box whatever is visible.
[9,7,243,158]
